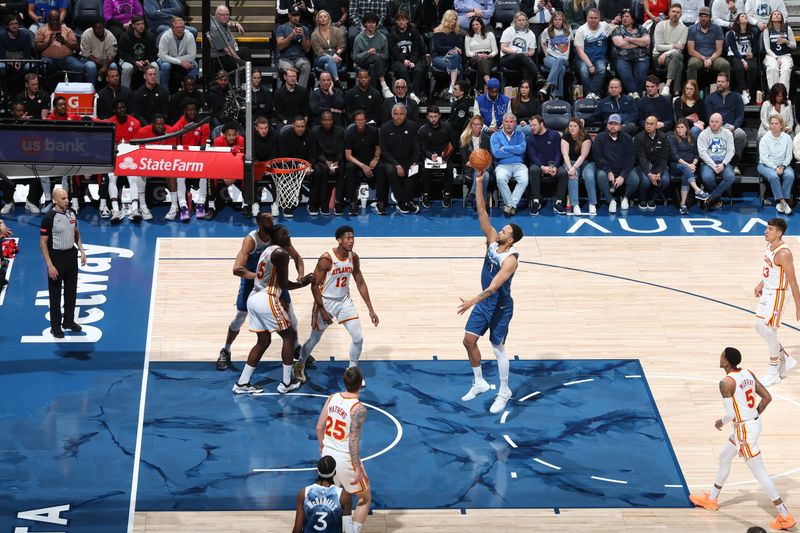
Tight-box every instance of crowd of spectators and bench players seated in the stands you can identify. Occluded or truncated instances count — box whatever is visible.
[0,0,800,223]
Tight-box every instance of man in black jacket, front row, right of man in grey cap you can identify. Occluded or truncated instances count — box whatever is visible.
[633,115,669,211]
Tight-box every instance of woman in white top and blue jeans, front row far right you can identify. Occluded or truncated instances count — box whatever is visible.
[758,115,794,215]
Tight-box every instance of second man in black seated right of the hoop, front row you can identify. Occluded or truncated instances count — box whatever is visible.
[344,110,386,216]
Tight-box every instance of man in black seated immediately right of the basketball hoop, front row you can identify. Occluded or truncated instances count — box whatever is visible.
[308,111,344,215]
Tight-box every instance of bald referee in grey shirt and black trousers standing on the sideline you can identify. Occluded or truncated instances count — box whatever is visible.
[39,189,86,339]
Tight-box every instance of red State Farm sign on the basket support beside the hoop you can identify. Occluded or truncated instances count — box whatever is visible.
[114,143,244,180]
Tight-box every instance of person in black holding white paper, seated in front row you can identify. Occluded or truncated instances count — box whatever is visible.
[419,105,458,209]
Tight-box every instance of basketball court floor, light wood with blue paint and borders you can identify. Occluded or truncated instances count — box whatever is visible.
[0,206,800,533]
